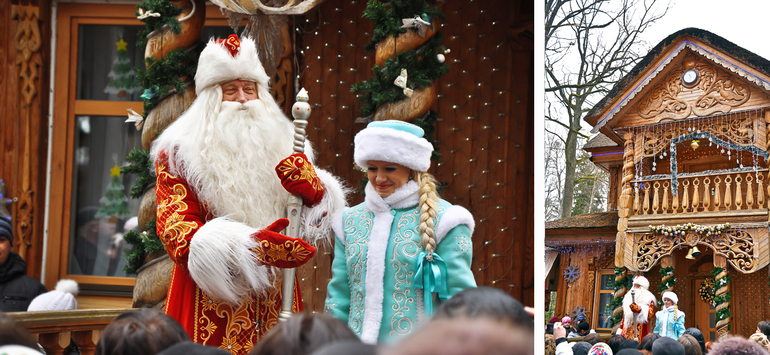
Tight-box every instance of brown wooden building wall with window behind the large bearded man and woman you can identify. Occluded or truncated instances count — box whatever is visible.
[0,0,534,311]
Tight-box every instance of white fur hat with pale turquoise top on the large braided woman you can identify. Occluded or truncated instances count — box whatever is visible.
[353,120,433,172]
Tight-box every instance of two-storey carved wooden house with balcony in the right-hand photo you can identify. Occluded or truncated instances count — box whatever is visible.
[545,28,770,340]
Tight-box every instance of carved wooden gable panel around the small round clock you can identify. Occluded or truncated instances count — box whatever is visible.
[637,54,751,122]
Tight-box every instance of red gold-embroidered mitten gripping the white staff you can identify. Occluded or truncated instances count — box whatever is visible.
[275,153,324,206]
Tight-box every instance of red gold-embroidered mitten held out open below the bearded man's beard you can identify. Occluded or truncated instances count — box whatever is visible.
[251,218,315,268]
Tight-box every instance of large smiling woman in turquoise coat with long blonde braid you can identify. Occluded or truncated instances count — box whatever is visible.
[325,120,476,344]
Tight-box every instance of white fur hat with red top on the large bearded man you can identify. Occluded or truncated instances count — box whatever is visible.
[195,35,270,94]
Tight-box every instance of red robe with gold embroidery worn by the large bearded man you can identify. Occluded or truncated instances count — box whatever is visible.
[155,156,312,354]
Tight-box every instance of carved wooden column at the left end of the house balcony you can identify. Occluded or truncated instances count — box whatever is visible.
[615,132,634,267]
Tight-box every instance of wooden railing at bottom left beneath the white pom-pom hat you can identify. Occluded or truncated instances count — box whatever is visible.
[6,309,131,355]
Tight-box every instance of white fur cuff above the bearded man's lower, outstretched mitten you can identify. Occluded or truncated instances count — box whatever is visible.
[187,218,271,304]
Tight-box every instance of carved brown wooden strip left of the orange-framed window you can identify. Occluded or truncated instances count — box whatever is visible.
[11,5,43,260]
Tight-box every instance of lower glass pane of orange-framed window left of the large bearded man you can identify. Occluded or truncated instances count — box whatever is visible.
[68,116,141,276]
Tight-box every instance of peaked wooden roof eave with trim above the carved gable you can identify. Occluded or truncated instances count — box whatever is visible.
[584,36,770,136]
